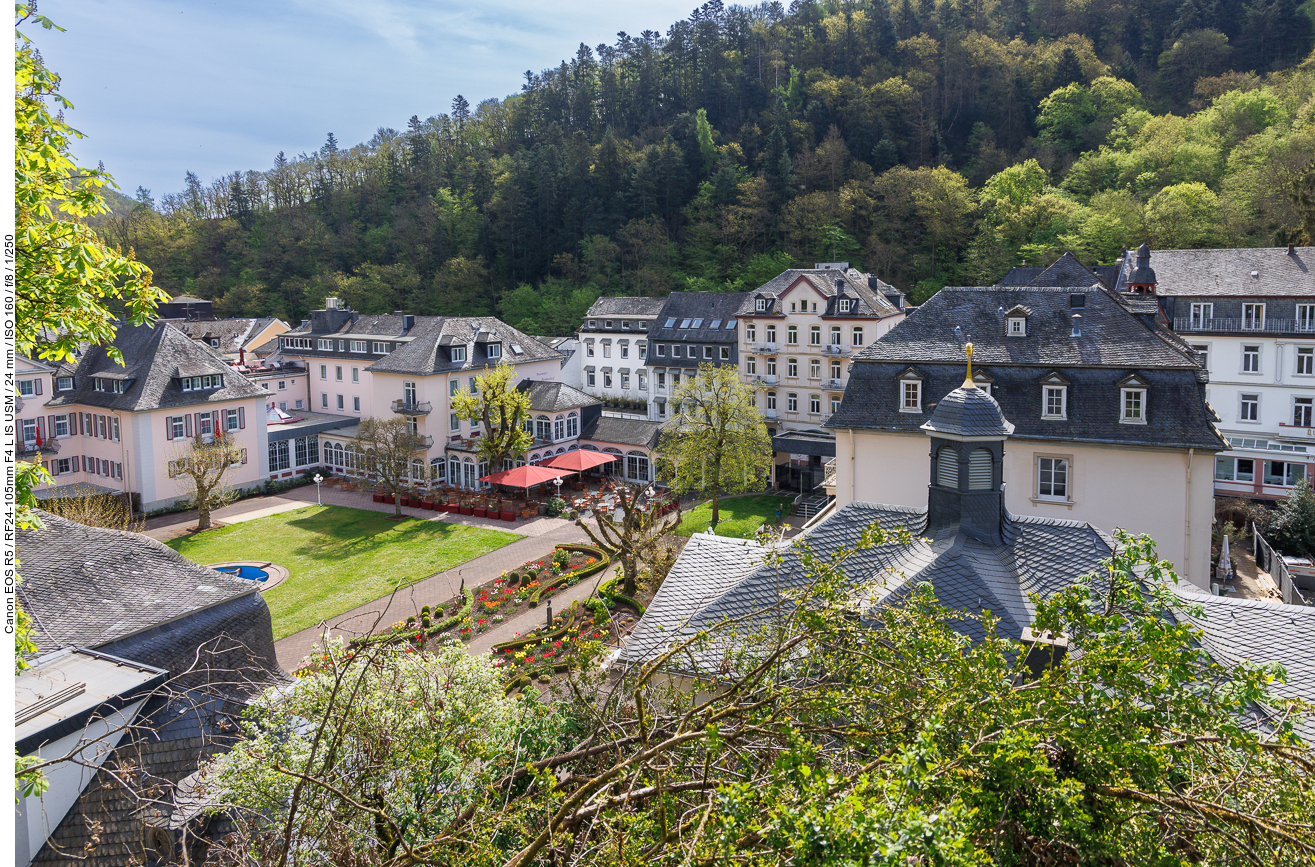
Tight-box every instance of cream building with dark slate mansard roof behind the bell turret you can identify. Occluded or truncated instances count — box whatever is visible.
[828,287,1226,588]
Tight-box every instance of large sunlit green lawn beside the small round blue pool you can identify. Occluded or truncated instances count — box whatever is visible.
[168,505,521,638]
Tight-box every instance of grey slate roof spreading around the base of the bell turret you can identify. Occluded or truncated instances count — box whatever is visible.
[622,503,1114,671]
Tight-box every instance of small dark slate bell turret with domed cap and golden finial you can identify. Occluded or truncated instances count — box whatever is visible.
[922,343,1014,543]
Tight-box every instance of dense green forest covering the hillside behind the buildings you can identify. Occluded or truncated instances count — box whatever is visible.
[100,0,1315,334]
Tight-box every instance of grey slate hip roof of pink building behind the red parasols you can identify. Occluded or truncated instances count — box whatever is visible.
[360,316,562,376]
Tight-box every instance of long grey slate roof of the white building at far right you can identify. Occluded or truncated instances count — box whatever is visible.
[1120,247,1315,297]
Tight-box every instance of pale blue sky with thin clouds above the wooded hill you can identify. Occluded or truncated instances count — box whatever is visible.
[24,0,697,200]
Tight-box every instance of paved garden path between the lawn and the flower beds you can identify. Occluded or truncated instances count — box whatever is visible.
[274,518,597,672]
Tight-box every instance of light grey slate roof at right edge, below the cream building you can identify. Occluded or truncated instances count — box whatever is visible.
[1177,594,1315,742]
